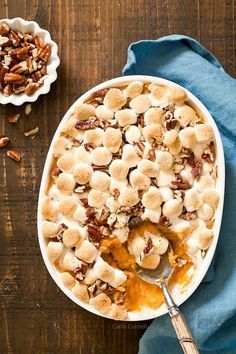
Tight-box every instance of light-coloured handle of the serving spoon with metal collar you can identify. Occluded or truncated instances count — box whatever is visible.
[160,282,199,354]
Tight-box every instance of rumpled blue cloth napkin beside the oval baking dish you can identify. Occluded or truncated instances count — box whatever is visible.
[123,35,236,354]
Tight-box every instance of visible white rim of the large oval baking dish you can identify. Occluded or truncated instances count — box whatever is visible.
[38,75,225,321]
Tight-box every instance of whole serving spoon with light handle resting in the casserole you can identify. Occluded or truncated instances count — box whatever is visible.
[132,219,199,354]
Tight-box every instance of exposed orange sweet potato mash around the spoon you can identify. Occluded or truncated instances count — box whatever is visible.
[100,223,192,311]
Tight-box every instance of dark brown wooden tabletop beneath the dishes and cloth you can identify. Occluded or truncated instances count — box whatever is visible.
[0,0,236,354]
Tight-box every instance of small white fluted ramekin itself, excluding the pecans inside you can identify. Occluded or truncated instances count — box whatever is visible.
[0,17,60,106]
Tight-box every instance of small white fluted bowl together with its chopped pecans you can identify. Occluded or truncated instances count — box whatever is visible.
[0,17,60,106]
